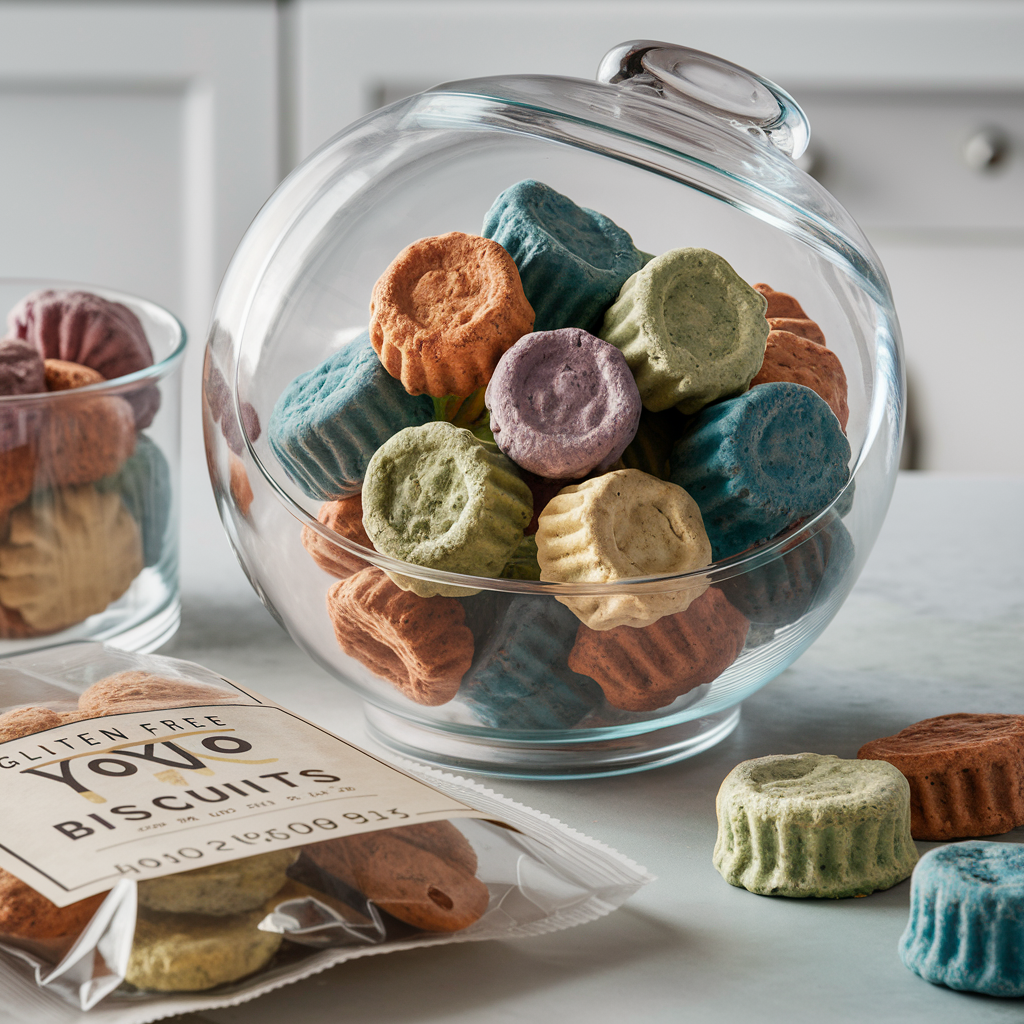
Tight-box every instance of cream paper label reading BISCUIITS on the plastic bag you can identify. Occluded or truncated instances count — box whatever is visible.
[0,688,486,906]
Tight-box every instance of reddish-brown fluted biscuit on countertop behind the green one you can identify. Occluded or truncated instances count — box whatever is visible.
[857,714,1024,841]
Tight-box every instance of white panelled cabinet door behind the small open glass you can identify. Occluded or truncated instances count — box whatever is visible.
[0,0,279,577]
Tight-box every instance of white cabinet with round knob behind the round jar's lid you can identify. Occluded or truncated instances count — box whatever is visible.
[289,0,1024,473]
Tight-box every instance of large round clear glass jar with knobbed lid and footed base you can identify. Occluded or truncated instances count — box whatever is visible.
[204,42,904,778]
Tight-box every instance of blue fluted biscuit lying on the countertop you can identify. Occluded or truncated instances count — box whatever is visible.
[899,841,1024,996]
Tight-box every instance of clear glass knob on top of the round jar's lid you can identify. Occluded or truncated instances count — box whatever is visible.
[597,40,811,159]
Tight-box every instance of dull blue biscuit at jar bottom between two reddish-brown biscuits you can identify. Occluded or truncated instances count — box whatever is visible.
[459,595,604,729]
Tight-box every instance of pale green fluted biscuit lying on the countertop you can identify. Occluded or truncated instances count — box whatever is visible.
[713,754,918,899]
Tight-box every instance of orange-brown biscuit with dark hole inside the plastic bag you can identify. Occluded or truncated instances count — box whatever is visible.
[303,821,489,932]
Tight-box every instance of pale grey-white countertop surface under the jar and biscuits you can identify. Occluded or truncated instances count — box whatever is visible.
[134,474,1024,1024]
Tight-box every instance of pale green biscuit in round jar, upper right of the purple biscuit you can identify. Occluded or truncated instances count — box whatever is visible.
[601,249,769,414]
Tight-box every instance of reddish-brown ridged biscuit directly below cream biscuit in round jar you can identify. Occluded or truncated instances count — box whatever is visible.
[568,587,751,711]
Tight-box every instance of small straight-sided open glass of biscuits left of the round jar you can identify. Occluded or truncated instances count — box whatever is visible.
[0,279,185,656]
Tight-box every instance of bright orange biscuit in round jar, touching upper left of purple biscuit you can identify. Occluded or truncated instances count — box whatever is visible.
[370,231,534,397]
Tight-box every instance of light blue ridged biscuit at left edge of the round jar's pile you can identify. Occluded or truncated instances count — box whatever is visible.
[268,331,434,501]
